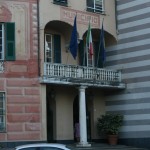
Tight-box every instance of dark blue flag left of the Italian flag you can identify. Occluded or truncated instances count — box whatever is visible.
[69,16,78,59]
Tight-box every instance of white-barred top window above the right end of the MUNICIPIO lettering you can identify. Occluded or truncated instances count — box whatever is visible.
[86,0,104,14]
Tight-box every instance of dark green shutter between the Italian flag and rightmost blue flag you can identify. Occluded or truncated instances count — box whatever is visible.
[94,42,103,68]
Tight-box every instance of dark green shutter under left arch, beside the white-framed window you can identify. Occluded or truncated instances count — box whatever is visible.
[54,34,61,63]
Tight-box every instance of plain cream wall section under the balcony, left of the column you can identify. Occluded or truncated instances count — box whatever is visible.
[56,87,77,140]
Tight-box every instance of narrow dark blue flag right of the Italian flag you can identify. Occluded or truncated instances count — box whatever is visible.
[100,22,106,64]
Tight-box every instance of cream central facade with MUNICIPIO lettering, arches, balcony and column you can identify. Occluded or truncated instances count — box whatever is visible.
[39,0,125,146]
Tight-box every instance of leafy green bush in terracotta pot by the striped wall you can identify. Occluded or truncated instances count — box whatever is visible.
[97,114,123,145]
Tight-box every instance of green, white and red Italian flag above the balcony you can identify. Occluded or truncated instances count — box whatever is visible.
[86,22,93,57]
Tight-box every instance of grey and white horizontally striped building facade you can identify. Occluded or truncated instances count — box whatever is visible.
[106,0,150,148]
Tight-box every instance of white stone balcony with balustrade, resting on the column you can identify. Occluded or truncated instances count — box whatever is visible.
[41,63,124,87]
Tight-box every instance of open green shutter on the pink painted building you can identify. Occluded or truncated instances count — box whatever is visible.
[5,22,15,60]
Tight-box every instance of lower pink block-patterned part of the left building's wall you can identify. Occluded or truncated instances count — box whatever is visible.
[0,78,41,141]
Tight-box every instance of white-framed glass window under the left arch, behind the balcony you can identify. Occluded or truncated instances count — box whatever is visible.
[44,33,54,63]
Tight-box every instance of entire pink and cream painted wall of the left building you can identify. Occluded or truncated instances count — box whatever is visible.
[0,0,42,142]
